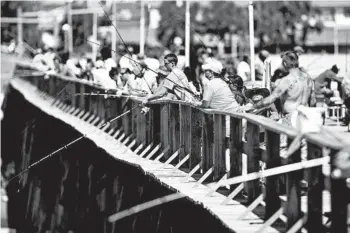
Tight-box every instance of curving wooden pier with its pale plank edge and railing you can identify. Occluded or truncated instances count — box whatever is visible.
[5,60,350,233]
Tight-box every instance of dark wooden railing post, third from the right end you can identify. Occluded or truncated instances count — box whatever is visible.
[286,138,303,229]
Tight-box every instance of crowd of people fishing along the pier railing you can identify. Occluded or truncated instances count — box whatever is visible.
[29,42,350,129]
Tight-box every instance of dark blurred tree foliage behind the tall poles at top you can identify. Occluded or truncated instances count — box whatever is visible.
[158,1,322,47]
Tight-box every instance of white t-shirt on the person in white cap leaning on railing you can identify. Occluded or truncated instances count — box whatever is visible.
[203,78,239,111]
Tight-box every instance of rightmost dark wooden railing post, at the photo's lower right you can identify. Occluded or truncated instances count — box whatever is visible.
[330,150,350,233]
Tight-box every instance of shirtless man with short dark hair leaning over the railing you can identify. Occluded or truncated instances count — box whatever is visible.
[253,51,316,124]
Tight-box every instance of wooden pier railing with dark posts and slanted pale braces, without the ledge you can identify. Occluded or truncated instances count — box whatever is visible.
[17,64,349,233]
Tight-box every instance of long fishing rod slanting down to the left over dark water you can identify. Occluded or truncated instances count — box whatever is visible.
[8,104,142,183]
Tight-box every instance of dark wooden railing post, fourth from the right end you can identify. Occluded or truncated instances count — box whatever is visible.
[265,130,281,220]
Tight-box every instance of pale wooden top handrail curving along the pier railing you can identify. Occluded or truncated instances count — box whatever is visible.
[16,60,349,150]
